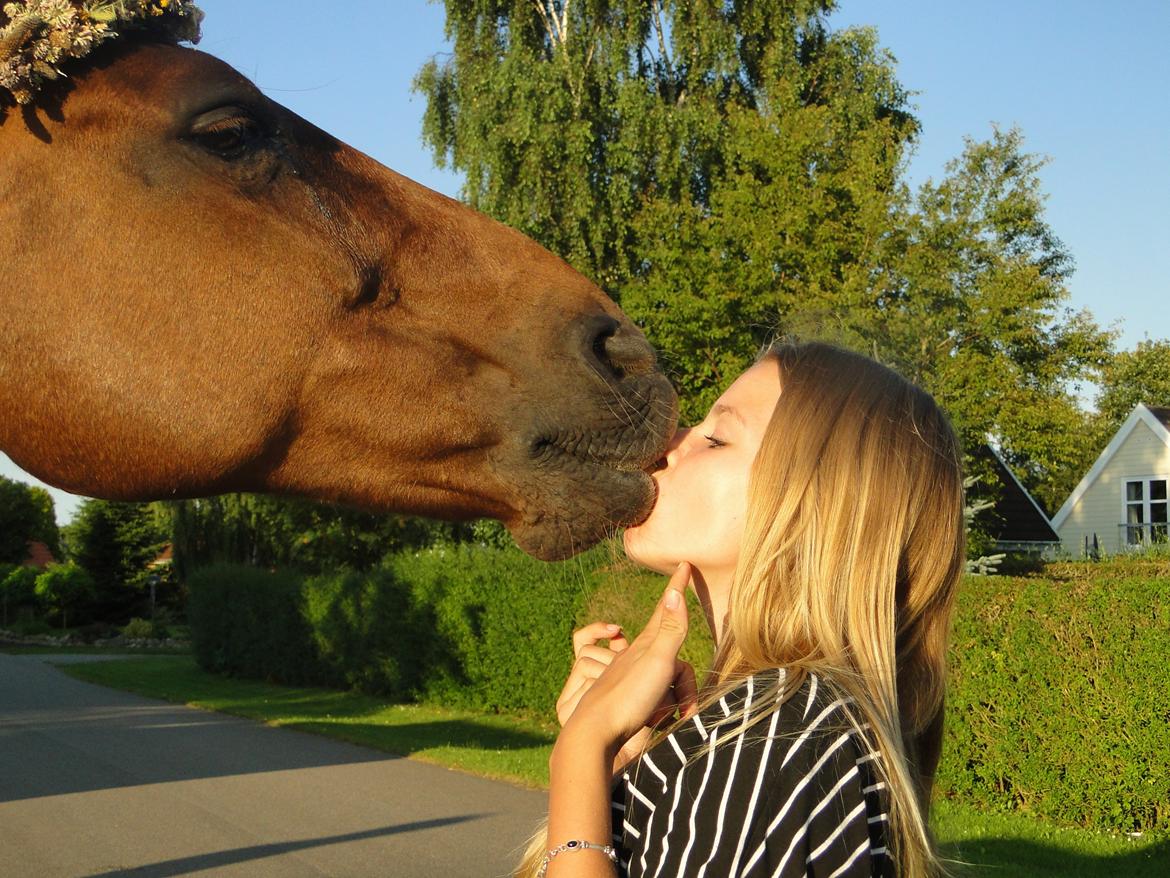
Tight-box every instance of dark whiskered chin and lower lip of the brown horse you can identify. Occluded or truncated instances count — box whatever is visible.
[508,464,656,561]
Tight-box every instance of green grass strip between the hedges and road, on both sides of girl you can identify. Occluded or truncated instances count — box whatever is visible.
[62,656,1170,878]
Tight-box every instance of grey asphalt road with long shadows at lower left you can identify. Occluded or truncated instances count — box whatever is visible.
[0,654,545,878]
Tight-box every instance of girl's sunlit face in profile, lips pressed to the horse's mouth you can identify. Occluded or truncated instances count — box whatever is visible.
[625,357,780,577]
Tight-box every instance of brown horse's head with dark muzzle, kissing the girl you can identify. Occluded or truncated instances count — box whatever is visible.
[0,32,676,558]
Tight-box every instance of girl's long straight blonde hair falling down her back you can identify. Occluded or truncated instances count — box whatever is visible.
[517,342,964,878]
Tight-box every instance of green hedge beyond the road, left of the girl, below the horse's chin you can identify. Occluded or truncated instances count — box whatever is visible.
[187,546,599,714]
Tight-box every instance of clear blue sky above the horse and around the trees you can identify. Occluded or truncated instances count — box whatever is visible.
[0,0,1170,521]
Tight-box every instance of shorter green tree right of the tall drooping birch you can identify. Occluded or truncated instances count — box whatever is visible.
[847,130,1112,510]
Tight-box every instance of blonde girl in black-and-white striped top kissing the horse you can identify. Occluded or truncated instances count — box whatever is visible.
[519,343,964,878]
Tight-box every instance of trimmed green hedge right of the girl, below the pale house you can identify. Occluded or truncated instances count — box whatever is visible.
[938,561,1170,831]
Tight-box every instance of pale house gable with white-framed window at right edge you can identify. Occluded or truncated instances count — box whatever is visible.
[1052,405,1170,556]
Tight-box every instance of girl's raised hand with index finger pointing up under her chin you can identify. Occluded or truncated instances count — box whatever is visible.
[557,563,697,753]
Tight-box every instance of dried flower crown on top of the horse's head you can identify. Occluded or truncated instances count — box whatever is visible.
[0,0,204,104]
